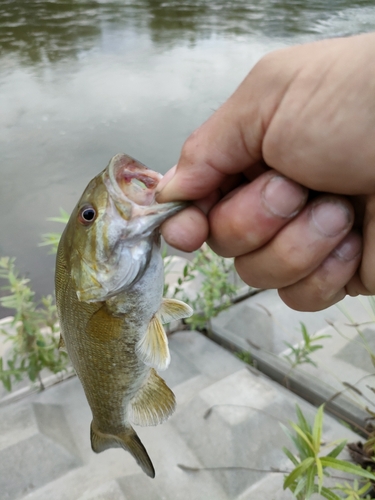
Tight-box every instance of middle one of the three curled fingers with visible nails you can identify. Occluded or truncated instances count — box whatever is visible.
[236,195,354,288]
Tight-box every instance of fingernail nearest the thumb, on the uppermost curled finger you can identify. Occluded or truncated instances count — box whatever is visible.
[262,175,307,217]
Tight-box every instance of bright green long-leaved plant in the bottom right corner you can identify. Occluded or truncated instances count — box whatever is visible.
[282,405,375,500]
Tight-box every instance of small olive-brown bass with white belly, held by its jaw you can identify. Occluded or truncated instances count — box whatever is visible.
[55,154,193,478]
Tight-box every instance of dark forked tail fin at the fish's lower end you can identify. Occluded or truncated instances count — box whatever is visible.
[90,422,155,477]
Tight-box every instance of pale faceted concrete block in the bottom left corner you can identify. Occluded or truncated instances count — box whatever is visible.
[0,402,82,500]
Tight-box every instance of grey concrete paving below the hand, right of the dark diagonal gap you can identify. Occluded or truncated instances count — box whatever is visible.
[212,290,375,427]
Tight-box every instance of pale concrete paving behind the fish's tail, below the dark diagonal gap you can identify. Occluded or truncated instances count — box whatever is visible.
[0,332,366,500]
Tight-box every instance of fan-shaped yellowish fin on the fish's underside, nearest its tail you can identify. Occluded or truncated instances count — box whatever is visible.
[129,369,176,425]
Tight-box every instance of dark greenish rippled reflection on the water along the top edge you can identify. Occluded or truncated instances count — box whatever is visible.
[0,0,373,64]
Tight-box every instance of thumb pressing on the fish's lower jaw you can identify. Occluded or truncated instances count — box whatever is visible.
[157,52,285,202]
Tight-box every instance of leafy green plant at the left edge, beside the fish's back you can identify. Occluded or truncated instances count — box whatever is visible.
[0,257,67,391]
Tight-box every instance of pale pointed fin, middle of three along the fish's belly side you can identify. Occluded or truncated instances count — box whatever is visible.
[135,314,171,370]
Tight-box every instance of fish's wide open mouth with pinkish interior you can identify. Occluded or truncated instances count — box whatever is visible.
[104,154,162,210]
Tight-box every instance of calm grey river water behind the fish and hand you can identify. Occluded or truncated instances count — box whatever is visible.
[0,0,375,315]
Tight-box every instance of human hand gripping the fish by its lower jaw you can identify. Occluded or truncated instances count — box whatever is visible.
[157,34,375,311]
